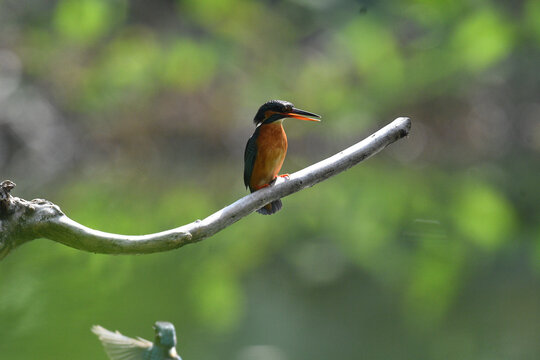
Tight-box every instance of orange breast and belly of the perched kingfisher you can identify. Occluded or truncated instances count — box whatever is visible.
[249,121,287,191]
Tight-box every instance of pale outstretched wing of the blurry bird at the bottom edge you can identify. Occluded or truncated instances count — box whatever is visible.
[92,325,152,360]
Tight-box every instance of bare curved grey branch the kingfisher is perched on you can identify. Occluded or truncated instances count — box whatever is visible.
[0,117,411,259]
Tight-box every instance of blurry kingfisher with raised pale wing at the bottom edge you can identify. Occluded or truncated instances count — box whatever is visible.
[92,321,182,360]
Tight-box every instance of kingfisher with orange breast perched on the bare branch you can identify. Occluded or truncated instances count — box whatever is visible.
[244,100,320,215]
